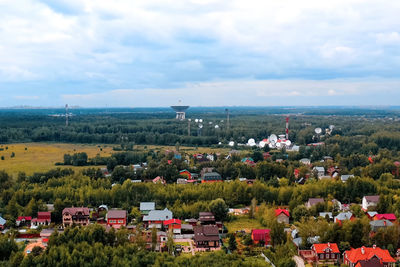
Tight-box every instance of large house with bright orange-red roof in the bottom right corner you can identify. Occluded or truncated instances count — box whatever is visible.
[343,245,396,267]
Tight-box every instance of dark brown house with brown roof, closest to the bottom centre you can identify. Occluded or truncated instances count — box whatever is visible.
[193,225,220,249]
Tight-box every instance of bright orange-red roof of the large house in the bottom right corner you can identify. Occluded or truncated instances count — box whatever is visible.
[344,246,396,263]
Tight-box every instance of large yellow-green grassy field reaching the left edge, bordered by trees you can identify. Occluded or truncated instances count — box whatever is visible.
[0,143,112,175]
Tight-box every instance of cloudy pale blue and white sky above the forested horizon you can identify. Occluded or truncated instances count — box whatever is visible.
[0,0,400,107]
